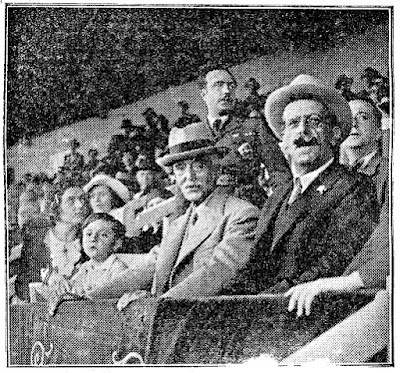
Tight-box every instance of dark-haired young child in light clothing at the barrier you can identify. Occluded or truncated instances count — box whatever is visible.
[70,213,128,296]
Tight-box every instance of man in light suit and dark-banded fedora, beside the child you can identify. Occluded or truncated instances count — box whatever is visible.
[89,123,258,298]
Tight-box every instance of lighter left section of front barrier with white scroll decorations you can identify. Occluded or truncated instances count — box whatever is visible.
[9,299,157,365]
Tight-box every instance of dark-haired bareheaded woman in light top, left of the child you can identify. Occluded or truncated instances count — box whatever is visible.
[15,183,89,301]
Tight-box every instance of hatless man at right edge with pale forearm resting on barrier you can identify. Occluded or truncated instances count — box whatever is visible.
[286,92,390,316]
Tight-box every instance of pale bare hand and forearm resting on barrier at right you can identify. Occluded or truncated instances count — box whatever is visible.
[285,272,364,317]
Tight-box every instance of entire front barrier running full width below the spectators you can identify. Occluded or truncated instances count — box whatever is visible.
[8,291,389,366]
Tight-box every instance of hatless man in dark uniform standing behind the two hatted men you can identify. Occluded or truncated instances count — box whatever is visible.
[199,67,290,206]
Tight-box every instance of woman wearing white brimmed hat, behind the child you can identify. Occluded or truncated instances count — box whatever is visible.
[83,174,130,221]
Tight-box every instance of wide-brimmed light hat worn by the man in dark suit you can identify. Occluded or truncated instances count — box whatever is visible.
[265,74,352,141]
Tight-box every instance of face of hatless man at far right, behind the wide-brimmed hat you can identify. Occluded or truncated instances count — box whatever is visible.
[344,100,381,148]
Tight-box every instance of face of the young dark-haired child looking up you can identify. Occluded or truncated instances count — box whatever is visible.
[82,220,117,262]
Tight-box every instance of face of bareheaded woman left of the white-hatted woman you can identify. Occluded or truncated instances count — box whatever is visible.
[59,187,88,224]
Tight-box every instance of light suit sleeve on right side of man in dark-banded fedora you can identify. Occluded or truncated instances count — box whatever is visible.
[163,206,259,298]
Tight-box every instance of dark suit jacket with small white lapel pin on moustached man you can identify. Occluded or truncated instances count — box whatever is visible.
[228,164,379,294]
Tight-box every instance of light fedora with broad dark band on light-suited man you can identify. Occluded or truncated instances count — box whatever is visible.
[156,122,223,167]
